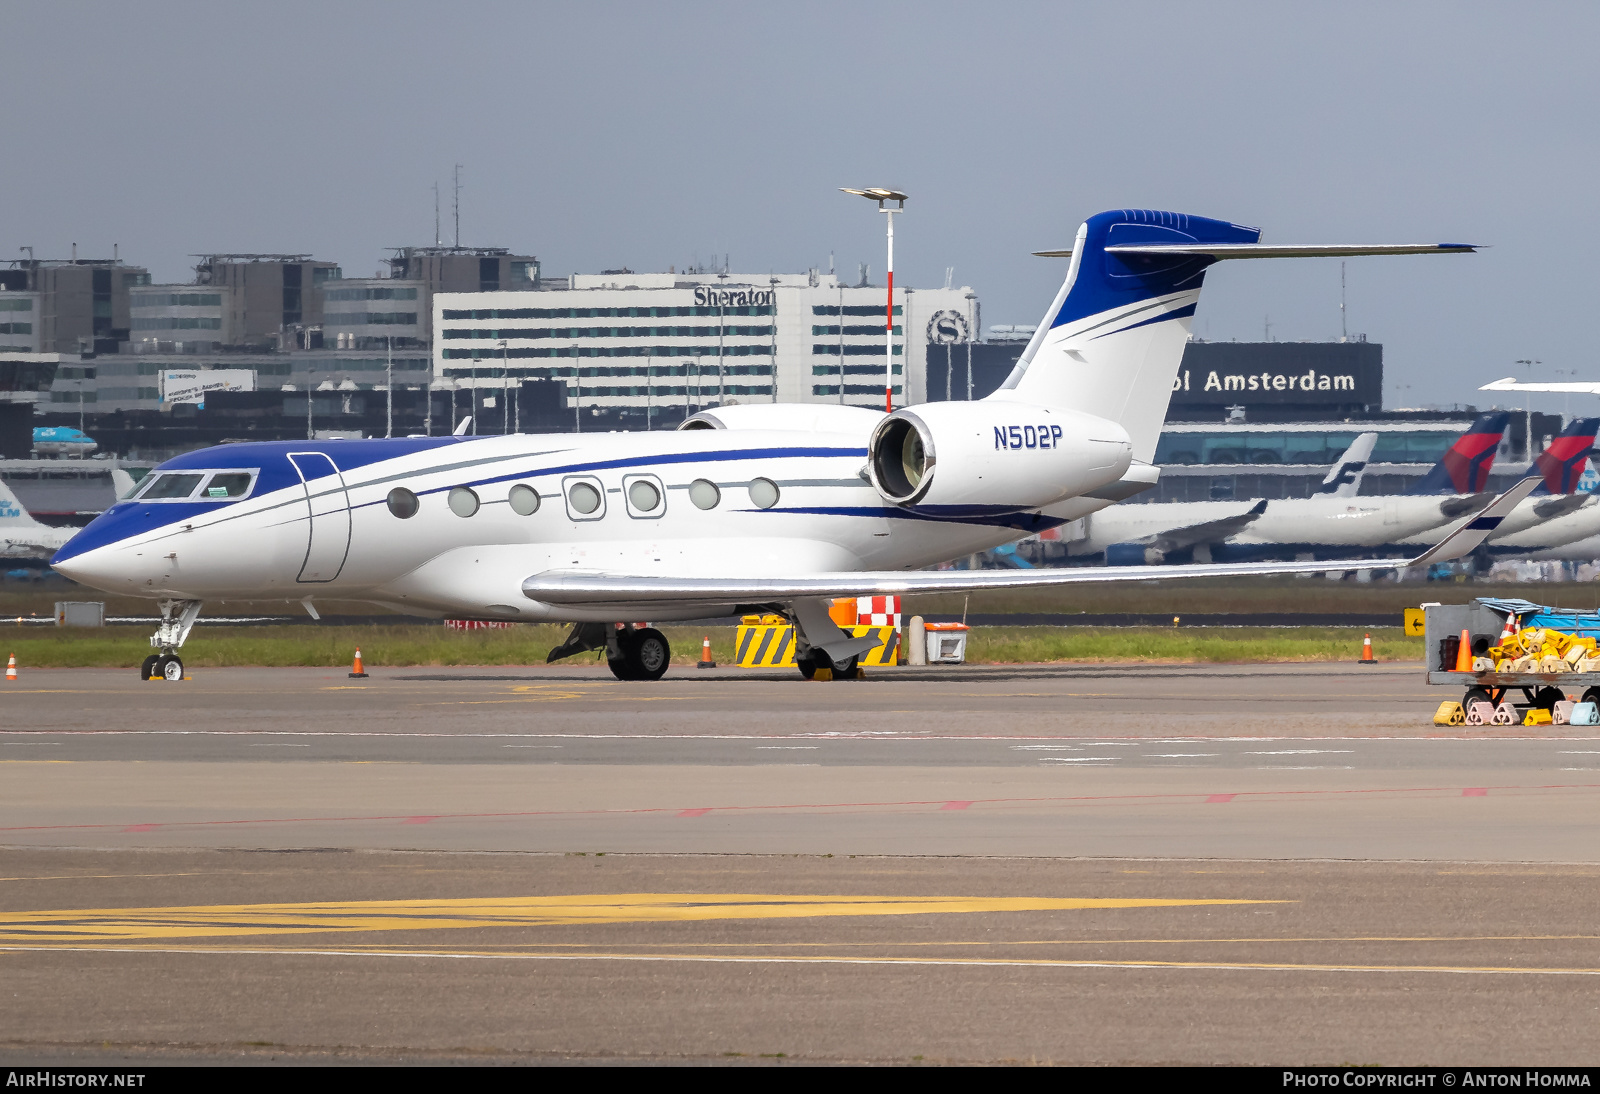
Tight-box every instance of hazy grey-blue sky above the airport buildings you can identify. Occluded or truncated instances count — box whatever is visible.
[0,0,1600,411]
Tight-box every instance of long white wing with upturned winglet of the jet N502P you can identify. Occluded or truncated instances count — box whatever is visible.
[522,475,1541,605]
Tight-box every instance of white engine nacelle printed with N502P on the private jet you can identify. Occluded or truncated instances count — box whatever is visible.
[867,400,1133,517]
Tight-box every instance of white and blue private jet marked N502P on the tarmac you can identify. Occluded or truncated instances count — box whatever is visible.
[54,210,1497,678]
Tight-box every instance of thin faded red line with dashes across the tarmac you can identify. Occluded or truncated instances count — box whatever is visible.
[0,782,1600,832]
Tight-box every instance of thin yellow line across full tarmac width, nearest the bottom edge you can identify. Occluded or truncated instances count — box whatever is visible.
[0,944,1600,976]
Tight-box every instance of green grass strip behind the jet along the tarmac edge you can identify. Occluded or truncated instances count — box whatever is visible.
[0,624,1422,672]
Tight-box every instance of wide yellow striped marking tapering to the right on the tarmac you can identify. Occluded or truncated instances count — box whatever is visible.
[0,892,1288,945]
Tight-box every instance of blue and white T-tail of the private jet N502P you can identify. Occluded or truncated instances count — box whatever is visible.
[989,210,1474,464]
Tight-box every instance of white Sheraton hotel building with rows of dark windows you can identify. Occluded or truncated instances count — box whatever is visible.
[434,270,978,416]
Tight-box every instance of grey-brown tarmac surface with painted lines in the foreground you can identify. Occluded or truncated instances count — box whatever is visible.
[0,665,1600,1064]
